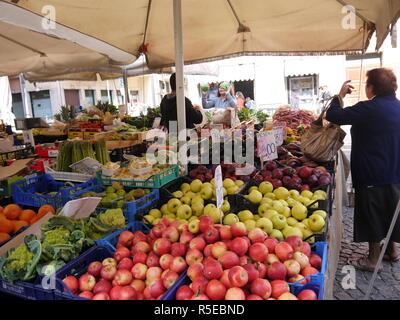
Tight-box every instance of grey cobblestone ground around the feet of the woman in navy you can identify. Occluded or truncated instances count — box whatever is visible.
[333,208,400,300]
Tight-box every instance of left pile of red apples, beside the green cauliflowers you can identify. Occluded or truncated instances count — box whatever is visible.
[63,225,193,300]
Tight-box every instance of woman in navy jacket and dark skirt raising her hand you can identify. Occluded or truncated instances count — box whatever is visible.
[326,68,400,271]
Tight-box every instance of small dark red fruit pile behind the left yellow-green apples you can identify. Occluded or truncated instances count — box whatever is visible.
[189,162,255,182]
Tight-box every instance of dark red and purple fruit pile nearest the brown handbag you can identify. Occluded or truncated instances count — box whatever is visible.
[253,161,332,191]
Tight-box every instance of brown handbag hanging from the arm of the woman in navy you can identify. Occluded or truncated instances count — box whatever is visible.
[301,97,346,162]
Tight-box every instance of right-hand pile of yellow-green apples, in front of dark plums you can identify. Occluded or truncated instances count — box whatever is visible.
[223,181,327,242]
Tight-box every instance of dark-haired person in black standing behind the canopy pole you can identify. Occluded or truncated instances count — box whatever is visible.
[160,73,203,130]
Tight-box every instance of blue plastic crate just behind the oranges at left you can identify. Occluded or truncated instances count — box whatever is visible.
[12,174,96,209]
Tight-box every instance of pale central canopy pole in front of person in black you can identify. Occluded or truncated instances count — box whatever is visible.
[174,0,187,170]
